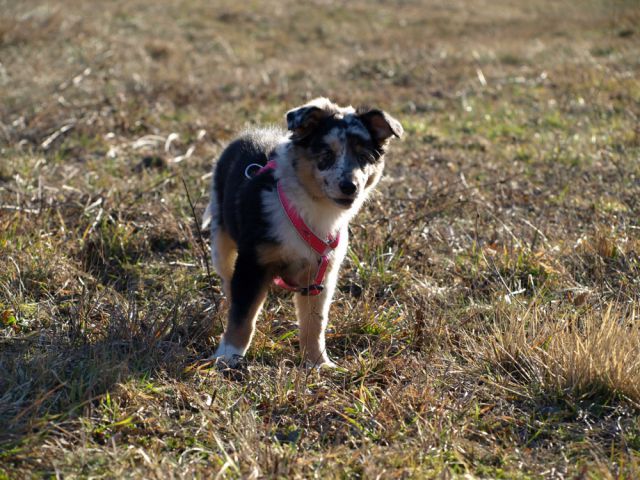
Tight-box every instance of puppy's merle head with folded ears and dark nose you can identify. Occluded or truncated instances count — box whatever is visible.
[287,98,403,209]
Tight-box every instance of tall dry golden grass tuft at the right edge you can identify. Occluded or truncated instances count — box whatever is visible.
[468,303,640,408]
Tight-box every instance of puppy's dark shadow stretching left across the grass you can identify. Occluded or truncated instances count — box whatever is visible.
[0,298,218,451]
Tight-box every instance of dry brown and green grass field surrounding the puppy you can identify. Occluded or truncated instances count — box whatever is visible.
[0,0,640,479]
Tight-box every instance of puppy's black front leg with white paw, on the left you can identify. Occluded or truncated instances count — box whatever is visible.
[213,252,268,362]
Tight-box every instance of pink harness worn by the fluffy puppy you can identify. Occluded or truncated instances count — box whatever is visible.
[250,154,340,296]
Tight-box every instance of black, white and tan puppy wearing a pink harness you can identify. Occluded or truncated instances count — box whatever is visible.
[203,98,403,367]
